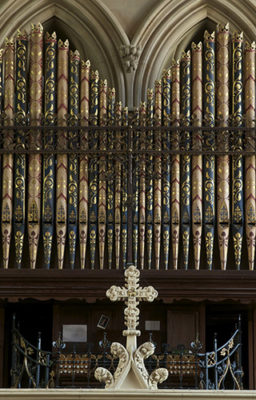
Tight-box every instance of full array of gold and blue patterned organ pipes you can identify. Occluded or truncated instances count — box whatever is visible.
[0,24,256,270]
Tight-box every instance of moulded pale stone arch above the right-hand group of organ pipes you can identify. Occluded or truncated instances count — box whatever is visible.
[132,0,256,105]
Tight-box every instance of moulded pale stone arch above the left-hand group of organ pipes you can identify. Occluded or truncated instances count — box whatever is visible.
[0,0,129,101]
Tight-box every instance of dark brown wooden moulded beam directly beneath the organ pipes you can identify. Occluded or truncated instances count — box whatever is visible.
[0,269,256,303]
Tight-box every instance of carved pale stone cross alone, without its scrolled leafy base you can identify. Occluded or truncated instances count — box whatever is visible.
[106,265,158,350]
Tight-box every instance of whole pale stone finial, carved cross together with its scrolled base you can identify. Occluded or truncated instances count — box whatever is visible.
[95,265,168,390]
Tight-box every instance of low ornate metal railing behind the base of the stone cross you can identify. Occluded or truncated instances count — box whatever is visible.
[11,320,243,390]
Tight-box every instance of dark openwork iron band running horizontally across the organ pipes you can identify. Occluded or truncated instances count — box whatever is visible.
[0,116,256,155]
